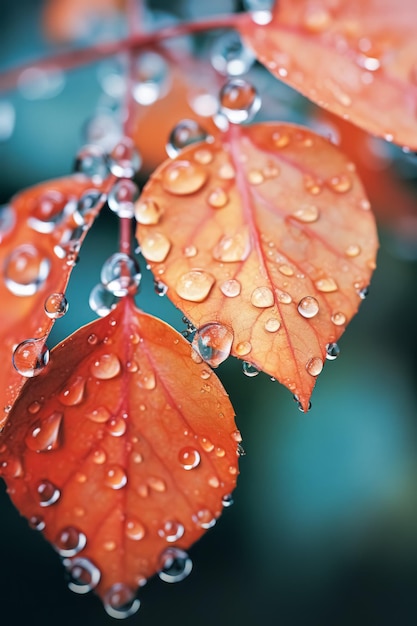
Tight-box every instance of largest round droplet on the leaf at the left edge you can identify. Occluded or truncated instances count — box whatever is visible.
[4,244,51,296]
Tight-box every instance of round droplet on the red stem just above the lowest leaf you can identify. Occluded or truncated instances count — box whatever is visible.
[100,252,141,297]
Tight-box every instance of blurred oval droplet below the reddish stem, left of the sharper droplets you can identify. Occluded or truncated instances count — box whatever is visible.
[132,51,170,106]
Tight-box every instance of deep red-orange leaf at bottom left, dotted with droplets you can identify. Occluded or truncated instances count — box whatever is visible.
[0,298,239,616]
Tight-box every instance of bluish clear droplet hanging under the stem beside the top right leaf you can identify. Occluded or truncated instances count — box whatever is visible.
[211,31,255,76]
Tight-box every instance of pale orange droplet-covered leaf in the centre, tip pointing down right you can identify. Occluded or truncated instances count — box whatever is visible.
[136,123,378,409]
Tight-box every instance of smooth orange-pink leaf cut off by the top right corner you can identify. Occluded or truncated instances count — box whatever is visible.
[240,0,417,148]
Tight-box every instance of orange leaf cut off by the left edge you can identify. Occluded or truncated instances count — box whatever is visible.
[0,175,109,430]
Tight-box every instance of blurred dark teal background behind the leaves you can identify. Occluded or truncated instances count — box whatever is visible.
[0,1,417,626]
